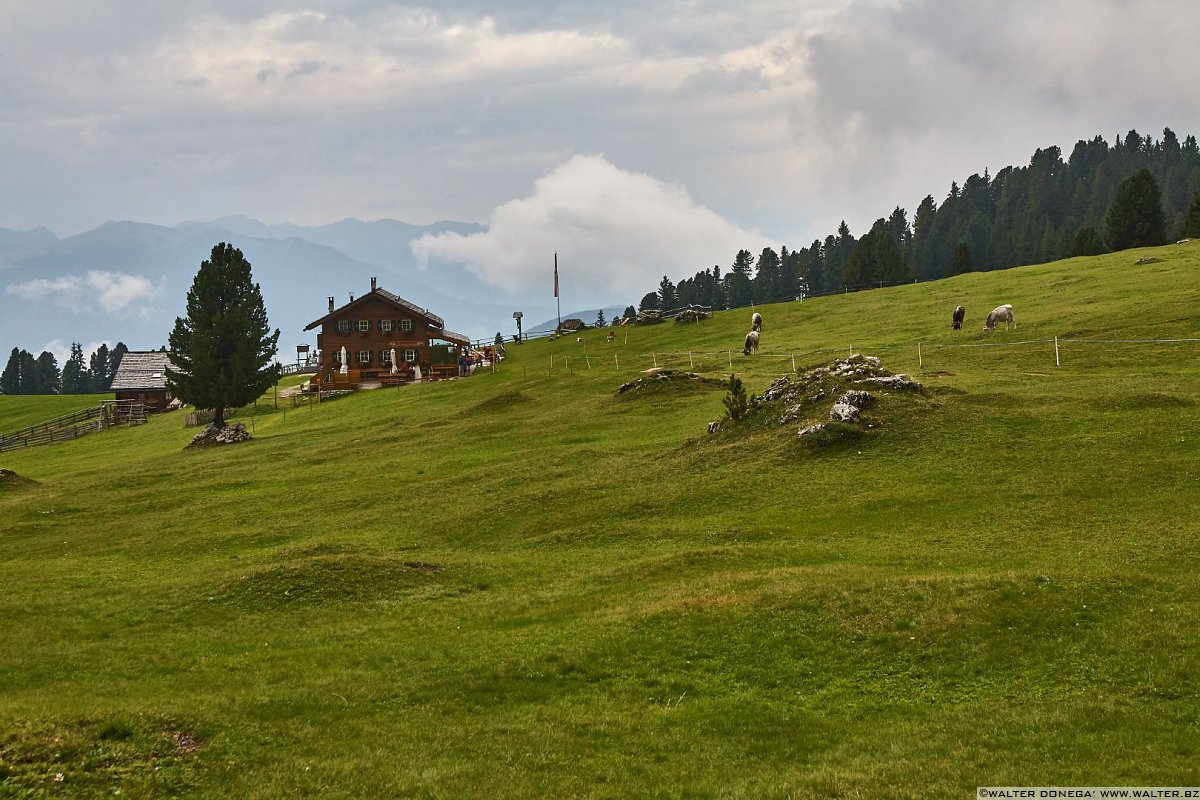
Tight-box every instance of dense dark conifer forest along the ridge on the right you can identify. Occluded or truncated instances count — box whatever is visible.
[626,128,1200,315]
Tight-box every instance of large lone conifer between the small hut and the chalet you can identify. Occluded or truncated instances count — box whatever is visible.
[167,242,280,427]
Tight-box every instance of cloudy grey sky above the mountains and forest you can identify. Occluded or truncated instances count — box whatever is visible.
[0,0,1200,305]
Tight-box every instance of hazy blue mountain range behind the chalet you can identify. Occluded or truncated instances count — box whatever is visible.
[0,216,612,362]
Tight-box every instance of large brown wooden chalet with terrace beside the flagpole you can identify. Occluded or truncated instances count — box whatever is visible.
[305,278,470,384]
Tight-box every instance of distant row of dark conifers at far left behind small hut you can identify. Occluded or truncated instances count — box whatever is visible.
[0,342,128,395]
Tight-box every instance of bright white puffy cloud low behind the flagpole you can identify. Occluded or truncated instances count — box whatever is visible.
[412,155,764,302]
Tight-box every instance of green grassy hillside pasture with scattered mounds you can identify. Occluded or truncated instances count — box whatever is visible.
[0,243,1200,798]
